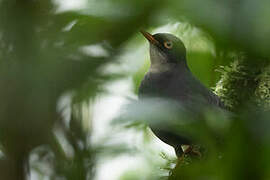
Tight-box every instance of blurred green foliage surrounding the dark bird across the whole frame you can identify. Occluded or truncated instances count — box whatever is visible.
[0,0,270,180]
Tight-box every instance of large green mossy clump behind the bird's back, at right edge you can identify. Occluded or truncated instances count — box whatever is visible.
[215,53,270,110]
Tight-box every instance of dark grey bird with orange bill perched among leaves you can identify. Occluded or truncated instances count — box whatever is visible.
[138,30,225,157]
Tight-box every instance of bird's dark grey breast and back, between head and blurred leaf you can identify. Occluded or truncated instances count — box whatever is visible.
[139,64,224,108]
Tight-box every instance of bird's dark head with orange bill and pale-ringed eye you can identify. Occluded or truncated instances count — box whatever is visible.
[141,31,186,65]
